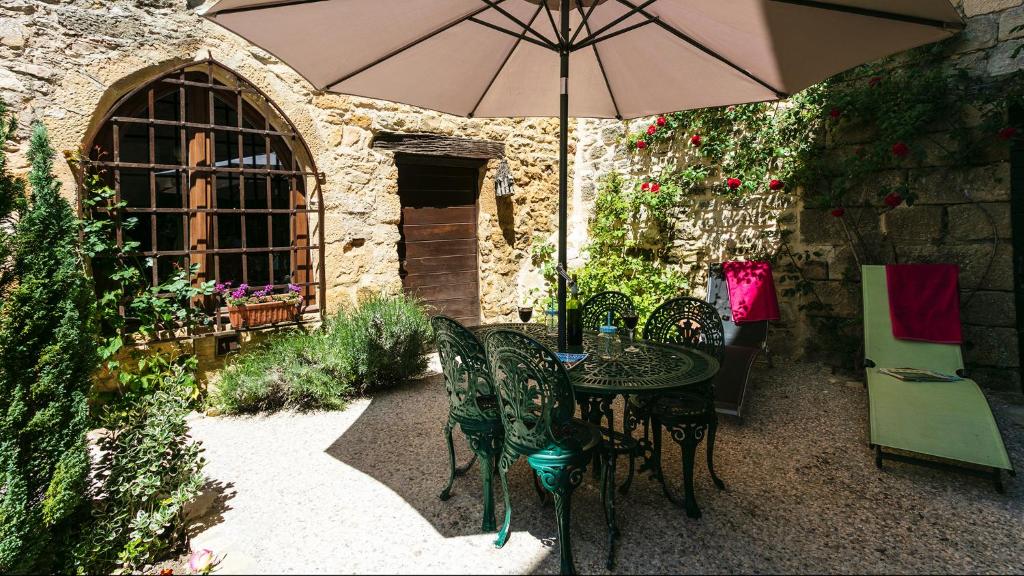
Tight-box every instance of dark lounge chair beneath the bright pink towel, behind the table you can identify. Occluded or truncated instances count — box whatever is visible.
[708,264,772,421]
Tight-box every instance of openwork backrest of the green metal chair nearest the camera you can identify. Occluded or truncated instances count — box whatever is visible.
[484,330,575,452]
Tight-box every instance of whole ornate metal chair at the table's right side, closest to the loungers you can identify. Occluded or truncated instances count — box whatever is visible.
[630,297,725,518]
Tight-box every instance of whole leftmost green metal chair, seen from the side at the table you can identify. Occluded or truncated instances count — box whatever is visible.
[430,316,505,532]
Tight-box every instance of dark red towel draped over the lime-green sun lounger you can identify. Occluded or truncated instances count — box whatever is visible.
[886,264,964,344]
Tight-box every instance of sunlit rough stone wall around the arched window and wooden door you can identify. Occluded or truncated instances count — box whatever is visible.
[0,0,577,332]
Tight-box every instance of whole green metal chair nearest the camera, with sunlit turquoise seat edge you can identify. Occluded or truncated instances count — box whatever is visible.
[484,330,611,574]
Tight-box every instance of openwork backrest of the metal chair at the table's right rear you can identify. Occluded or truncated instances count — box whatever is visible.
[643,297,725,360]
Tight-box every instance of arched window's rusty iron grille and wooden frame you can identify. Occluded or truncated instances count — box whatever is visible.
[83,58,326,332]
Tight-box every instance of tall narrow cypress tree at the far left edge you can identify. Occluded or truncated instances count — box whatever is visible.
[0,123,97,573]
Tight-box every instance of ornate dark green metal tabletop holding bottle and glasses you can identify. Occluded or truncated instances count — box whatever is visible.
[472,323,719,396]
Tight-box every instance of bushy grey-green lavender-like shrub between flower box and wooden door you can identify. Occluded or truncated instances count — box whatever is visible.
[214,296,431,413]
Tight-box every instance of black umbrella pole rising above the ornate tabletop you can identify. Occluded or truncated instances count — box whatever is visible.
[558,0,569,352]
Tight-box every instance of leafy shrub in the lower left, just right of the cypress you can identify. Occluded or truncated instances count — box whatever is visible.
[75,364,205,574]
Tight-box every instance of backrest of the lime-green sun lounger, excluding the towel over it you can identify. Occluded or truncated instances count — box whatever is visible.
[861,265,964,374]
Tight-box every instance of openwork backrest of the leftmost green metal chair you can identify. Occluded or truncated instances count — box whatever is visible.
[430,316,495,420]
